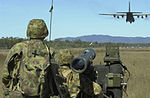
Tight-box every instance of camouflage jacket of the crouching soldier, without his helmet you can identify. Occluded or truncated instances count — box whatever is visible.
[59,66,102,98]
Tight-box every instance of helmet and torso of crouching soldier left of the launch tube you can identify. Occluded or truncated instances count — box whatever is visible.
[55,49,80,98]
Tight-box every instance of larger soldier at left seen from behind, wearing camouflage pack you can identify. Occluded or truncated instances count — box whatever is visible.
[2,19,72,98]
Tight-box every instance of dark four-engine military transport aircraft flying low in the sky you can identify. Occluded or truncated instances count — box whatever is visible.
[99,2,150,23]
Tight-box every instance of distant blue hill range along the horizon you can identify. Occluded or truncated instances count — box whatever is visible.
[59,35,150,43]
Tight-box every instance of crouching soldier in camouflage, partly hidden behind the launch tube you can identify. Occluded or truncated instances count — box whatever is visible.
[56,49,103,98]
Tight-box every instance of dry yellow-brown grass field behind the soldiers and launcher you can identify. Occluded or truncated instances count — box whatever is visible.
[0,48,150,98]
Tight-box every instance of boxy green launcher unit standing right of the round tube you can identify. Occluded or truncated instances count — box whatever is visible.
[94,45,130,98]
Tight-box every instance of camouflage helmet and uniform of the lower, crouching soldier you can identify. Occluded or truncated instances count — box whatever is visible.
[56,49,102,98]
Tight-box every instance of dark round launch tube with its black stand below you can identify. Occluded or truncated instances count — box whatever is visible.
[70,49,96,98]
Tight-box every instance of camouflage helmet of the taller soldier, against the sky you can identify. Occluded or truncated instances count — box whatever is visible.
[27,19,48,39]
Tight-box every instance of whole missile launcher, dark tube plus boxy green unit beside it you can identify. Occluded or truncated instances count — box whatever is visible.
[70,46,130,98]
